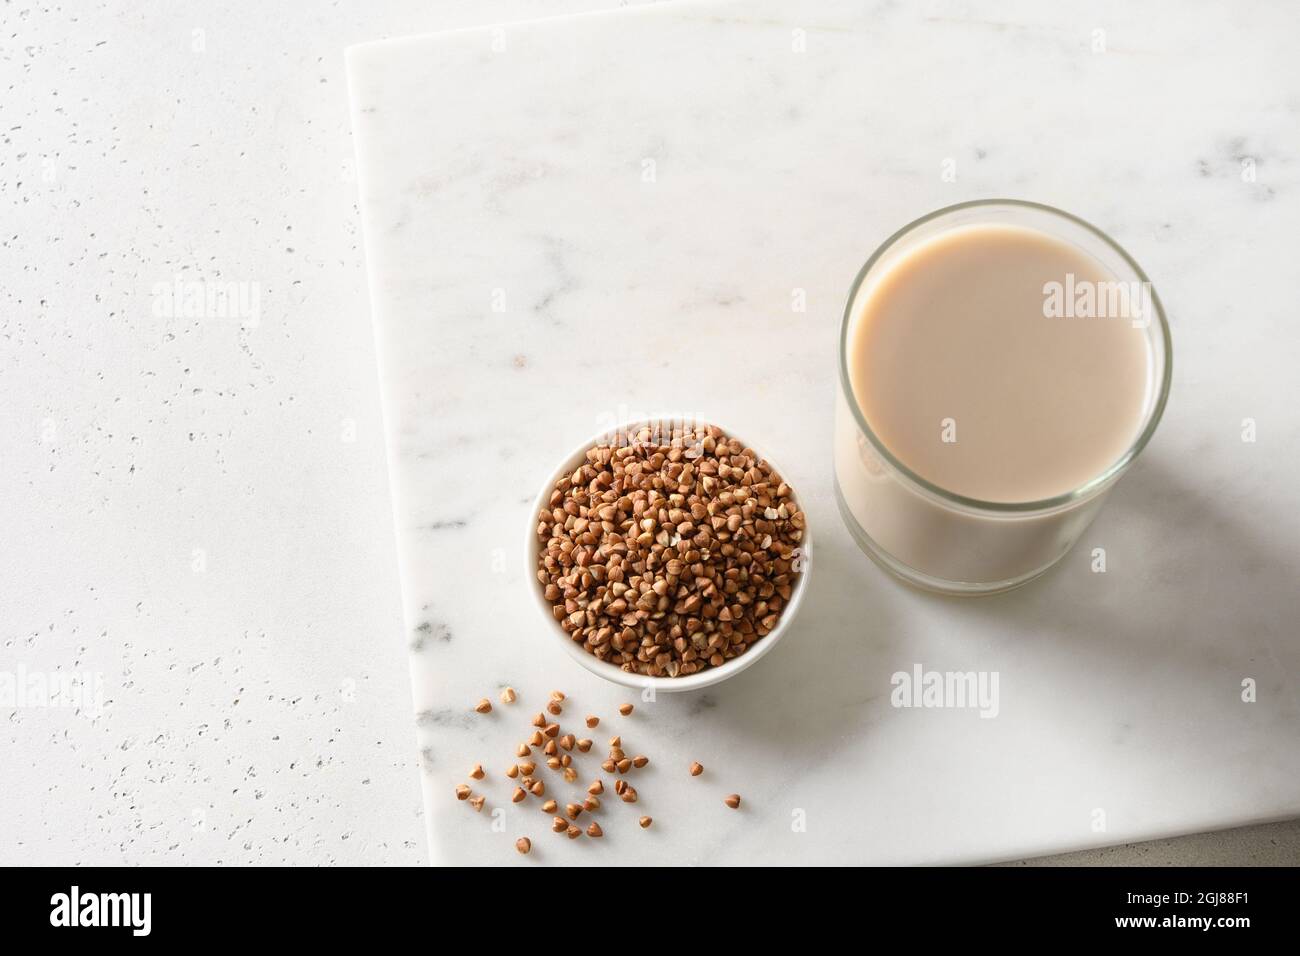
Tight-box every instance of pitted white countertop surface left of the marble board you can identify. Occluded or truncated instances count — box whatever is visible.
[0,0,637,864]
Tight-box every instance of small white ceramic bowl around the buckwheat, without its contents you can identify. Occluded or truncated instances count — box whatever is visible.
[524,416,813,693]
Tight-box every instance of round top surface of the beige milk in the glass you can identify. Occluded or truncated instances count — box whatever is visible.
[849,225,1148,502]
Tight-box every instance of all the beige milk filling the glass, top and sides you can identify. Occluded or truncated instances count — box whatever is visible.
[836,224,1152,583]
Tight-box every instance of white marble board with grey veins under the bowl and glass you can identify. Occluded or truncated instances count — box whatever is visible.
[348,0,1300,864]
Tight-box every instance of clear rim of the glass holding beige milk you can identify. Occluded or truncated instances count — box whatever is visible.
[839,199,1174,514]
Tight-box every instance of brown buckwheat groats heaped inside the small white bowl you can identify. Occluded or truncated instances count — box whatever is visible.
[537,424,805,678]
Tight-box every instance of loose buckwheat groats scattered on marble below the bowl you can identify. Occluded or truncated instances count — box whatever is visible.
[455,687,740,853]
